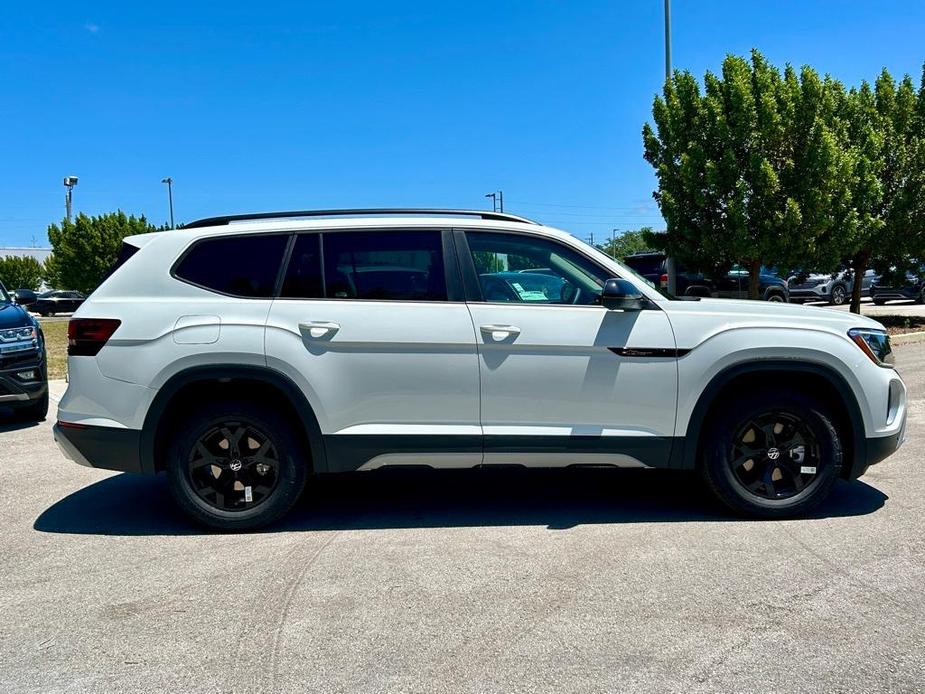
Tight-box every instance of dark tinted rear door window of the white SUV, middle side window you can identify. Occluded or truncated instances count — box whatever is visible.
[323,231,446,301]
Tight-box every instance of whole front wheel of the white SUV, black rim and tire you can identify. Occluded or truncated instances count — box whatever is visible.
[700,390,842,518]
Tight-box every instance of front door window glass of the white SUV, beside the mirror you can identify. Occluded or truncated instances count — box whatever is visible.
[466,231,607,305]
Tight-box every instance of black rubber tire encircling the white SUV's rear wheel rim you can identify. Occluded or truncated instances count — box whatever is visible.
[166,403,307,530]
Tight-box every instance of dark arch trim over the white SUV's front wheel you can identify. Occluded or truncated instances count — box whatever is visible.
[673,360,867,474]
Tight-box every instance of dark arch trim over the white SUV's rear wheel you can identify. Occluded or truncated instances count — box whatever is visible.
[140,364,327,473]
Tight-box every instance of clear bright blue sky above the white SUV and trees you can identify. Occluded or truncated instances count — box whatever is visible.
[0,0,925,246]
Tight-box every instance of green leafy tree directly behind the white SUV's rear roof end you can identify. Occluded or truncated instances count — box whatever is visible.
[48,210,156,293]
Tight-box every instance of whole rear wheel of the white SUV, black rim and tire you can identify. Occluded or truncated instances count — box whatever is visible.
[167,400,309,531]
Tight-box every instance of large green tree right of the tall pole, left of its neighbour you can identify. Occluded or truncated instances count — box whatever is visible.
[643,50,852,298]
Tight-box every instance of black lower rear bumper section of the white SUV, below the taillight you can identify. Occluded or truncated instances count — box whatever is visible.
[52,422,142,472]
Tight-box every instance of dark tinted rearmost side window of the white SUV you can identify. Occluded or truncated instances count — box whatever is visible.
[175,232,289,298]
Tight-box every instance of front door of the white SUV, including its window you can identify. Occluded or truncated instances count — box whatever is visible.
[457,231,678,466]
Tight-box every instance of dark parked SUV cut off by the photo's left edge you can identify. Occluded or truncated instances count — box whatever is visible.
[0,282,48,420]
